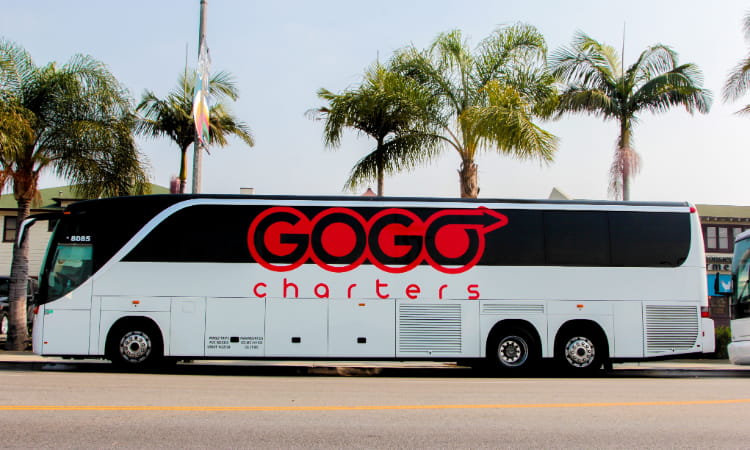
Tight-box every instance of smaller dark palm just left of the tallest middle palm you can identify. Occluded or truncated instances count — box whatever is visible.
[310,64,444,196]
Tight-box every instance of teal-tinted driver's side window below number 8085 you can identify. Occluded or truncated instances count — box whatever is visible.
[47,244,93,300]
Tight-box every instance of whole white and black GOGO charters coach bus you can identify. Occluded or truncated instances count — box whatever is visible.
[25,195,714,373]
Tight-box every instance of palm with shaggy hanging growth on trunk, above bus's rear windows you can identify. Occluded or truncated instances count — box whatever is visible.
[550,33,711,200]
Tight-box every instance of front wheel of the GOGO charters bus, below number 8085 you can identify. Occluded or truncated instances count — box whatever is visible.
[107,321,164,370]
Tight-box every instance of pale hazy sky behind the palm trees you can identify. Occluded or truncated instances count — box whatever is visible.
[0,0,750,205]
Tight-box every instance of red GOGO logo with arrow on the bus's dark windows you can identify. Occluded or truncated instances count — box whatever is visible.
[247,206,508,274]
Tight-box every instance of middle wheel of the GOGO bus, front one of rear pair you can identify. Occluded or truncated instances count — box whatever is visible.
[487,327,540,375]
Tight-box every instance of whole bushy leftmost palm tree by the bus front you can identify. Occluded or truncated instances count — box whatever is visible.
[0,39,148,350]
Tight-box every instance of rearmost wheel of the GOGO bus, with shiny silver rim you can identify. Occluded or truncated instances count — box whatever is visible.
[555,327,609,375]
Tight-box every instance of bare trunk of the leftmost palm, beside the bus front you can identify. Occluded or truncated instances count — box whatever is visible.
[5,198,31,351]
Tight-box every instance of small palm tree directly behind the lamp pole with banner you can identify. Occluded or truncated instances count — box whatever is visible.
[136,69,255,194]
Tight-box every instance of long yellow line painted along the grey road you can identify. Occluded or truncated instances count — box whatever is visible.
[0,398,750,412]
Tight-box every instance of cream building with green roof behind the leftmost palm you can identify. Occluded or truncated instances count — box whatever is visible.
[0,185,169,277]
